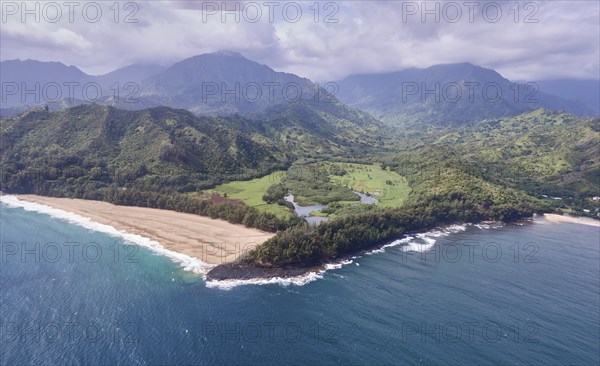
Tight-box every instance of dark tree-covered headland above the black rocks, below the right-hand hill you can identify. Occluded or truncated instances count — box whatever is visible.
[245,152,550,266]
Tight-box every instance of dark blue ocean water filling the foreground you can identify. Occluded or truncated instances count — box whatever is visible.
[0,206,600,365]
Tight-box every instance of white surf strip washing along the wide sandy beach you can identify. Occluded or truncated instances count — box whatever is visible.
[0,196,214,276]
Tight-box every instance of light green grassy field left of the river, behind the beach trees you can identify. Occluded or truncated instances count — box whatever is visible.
[210,171,292,218]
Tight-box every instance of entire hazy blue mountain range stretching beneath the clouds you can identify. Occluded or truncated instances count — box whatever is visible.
[1,51,600,130]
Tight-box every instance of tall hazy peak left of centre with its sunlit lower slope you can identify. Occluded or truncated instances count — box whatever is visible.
[135,51,381,156]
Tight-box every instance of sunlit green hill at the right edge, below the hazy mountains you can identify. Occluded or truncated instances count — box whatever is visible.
[433,109,600,198]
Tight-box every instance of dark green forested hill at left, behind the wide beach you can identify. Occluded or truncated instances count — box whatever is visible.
[0,105,289,193]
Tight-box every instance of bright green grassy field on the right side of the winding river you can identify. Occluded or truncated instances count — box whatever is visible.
[331,163,410,207]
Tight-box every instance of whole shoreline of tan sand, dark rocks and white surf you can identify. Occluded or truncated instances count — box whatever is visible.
[7,195,600,287]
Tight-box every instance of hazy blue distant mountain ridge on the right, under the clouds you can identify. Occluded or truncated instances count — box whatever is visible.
[337,62,594,127]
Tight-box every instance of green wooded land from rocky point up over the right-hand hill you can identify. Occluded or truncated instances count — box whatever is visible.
[245,110,600,266]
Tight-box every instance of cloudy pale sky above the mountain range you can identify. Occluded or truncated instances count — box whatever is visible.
[0,0,600,81]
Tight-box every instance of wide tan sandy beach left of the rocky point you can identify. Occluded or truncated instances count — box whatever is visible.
[17,195,274,264]
